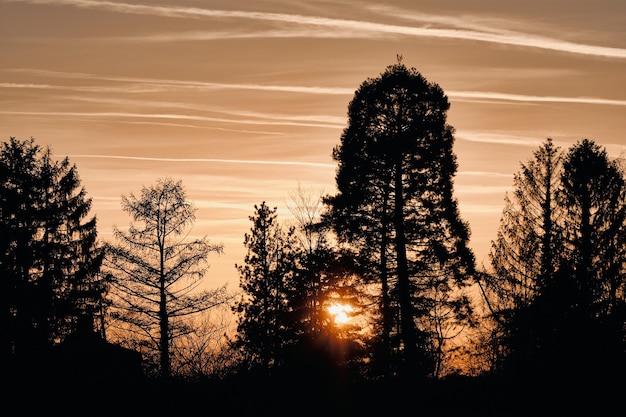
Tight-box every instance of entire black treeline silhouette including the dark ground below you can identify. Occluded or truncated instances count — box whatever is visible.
[0,61,626,416]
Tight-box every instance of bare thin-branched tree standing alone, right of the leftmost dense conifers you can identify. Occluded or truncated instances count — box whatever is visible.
[105,178,228,379]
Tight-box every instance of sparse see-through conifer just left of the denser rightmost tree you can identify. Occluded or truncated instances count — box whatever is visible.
[483,138,564,370]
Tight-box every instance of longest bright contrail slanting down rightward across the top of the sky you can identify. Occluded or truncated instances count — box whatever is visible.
[13,0,626,59]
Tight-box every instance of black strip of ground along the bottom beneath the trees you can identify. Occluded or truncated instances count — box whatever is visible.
[8,368,625,417]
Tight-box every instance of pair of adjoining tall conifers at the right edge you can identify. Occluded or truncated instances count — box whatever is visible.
[484,139,626,377]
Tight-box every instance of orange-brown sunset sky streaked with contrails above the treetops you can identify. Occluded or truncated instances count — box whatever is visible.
[0,0,626,289]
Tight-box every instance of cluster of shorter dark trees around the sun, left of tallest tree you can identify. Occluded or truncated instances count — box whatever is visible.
[233,200,362,376]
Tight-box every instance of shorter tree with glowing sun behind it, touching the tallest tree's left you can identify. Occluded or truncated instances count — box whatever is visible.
[288,186,364,377]
